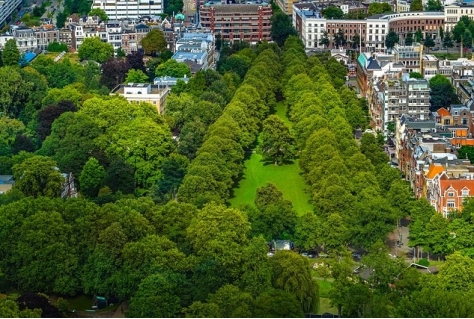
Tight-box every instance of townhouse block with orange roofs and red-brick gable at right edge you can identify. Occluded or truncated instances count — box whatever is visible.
[395,100,474,218]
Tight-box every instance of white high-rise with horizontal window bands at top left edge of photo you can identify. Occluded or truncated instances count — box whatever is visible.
[92,0,163,20]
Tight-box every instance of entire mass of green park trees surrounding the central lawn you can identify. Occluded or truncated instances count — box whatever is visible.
[0,28,474,317]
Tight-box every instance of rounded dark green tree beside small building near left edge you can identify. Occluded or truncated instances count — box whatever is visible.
[13,156,64,197]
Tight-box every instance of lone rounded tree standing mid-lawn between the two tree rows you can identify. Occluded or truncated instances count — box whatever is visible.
[260,115,295,165]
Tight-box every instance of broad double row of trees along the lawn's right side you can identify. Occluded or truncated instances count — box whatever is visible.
[283,38,410,251]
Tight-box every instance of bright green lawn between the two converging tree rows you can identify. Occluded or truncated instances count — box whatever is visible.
[229,102,313,215]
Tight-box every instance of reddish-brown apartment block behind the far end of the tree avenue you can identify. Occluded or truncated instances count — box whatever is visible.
[199,1,272,44]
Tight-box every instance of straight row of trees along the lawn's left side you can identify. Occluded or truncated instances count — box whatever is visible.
[178,49,280,207]
